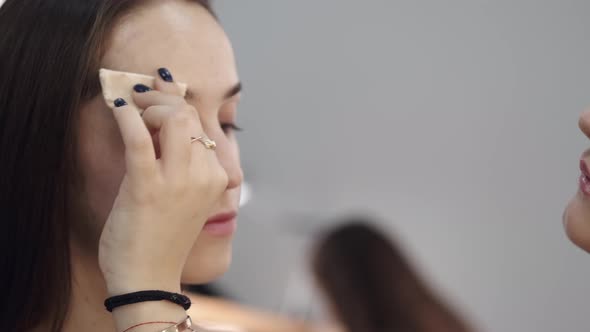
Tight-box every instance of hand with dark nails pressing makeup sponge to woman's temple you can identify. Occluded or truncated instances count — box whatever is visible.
[99,68,228,295]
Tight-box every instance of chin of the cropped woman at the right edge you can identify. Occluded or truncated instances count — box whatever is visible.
[563,199,590,253]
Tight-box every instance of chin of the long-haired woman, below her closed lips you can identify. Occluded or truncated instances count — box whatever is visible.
[182,234,232,285]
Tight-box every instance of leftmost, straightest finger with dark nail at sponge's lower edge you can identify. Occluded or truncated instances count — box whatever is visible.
[113,98,156,177]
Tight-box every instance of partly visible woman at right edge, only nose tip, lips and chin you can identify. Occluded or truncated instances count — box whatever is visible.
[563,111,590,252]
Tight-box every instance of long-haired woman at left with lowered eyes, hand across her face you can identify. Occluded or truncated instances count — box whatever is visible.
[0,0,242,332]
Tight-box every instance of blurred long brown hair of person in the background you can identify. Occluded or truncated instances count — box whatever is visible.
[312,218,468,332]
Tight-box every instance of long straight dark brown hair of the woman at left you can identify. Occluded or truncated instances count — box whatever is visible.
[0,0,211,331]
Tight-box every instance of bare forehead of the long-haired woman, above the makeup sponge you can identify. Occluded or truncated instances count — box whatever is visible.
[101,1,238,100]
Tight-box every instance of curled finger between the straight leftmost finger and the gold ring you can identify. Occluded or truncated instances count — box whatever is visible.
[158,105,202,176]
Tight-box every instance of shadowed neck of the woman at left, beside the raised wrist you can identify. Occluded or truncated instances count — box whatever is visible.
[62,243,116,332]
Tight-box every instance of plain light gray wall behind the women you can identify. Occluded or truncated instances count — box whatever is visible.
[215,0,590,332]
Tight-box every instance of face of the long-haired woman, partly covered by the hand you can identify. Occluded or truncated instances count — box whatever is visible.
[74,1,242,283]
